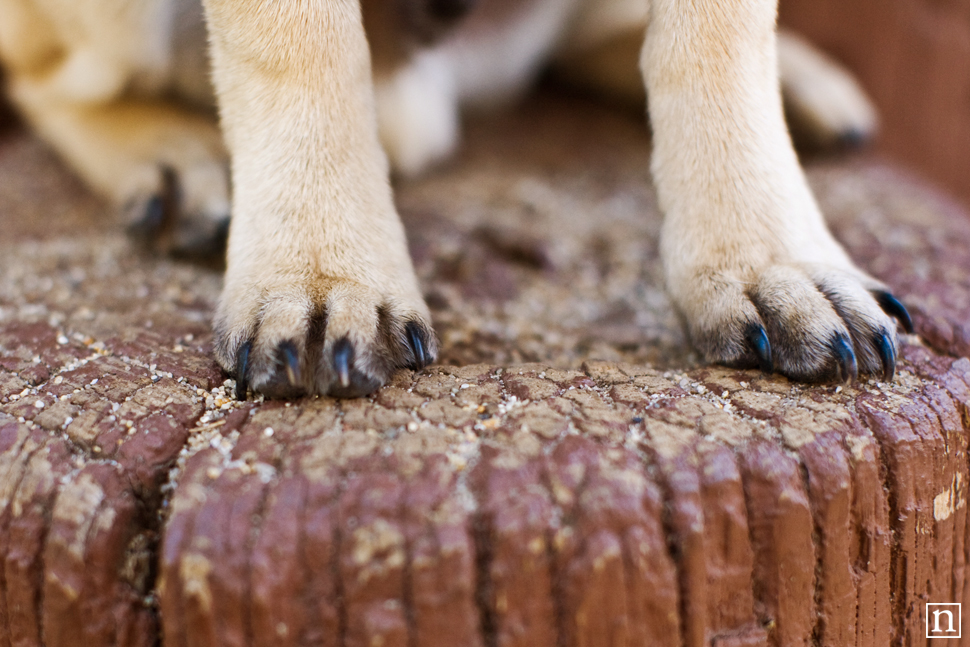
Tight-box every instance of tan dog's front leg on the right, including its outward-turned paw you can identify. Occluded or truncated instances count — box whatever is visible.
[641,0,908,381]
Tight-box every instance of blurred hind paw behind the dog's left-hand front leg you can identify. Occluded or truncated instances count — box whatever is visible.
[124,161,229,260]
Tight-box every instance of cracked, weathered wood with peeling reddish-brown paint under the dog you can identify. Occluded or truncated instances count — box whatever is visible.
[0,92,970,647]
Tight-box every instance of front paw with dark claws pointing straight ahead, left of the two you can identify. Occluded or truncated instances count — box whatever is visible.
[215,278,437,400]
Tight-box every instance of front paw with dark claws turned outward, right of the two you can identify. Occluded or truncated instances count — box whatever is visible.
[680,265,913,382]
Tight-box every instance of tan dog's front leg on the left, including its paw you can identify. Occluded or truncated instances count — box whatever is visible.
[205,0,435,397]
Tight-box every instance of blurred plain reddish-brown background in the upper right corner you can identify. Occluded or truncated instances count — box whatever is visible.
[779,0,970,205]
